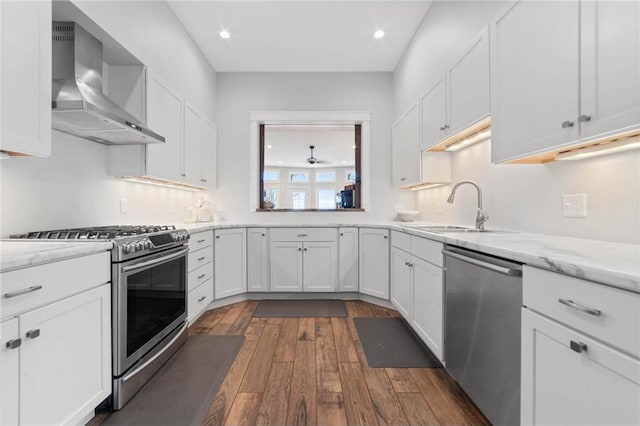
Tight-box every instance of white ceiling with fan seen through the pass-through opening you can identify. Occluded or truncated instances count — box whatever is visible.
[264,126,355,168]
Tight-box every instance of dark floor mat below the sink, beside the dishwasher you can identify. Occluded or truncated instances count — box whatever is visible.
[353,318,442,368]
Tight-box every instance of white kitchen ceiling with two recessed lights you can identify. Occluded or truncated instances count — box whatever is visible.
[168,0,431,72]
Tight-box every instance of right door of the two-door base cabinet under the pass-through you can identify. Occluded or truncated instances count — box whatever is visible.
[302,241,338,292]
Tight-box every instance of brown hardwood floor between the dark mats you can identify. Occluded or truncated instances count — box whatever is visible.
[189,301,489,425]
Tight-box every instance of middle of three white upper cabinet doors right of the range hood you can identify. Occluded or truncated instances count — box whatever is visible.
[184,102,204,185]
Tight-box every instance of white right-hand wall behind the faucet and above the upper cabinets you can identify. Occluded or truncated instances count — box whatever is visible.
[393,2,640,244]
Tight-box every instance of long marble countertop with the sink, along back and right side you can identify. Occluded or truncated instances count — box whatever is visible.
[176,222,640,292]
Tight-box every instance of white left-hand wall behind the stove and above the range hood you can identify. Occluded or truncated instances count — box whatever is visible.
[0,1,216,237]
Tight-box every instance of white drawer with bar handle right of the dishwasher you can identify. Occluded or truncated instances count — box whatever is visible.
[523,265,640,356]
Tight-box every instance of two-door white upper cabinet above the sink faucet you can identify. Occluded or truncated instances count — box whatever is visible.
[420,29,490,150]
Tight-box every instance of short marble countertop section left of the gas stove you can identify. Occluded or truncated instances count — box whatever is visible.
[0,240,113,272]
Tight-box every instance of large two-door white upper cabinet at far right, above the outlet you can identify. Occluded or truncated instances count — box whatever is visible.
[491,1,640,162]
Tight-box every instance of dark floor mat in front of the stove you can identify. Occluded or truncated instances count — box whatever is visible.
[103,335,244,426]
